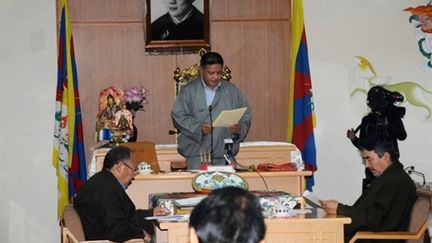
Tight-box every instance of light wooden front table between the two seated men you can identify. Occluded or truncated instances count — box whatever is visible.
[156,210,351,243]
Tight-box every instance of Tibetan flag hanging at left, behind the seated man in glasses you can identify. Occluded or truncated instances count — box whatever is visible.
[53,0,87,217]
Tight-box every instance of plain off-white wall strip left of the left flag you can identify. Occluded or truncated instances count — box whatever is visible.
[0,0,60,243]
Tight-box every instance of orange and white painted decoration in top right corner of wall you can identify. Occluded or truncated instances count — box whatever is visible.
[404,1,432,70]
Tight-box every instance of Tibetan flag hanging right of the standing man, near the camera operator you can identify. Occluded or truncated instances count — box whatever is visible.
[288,0,317,190]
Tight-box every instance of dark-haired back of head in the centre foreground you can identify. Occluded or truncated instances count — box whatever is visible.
[189,187,266,243]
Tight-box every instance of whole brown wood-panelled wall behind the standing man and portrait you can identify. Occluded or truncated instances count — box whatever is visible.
[62,0,291,161]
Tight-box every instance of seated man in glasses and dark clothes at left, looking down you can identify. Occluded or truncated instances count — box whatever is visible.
[74,146,163,242]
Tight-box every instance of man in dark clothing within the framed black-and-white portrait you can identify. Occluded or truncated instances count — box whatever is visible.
[151,0,204,40]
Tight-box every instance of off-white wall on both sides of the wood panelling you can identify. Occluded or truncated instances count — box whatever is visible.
[0,0,432,243]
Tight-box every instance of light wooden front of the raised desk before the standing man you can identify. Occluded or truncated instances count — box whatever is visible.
[127,171,312,208]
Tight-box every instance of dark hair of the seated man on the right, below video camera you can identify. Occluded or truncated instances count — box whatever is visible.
[358,136,397,162]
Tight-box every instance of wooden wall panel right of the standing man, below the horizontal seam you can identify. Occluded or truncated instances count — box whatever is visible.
[212,21,289,141]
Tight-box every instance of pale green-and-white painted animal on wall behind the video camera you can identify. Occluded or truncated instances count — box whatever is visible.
[351,56,432,121]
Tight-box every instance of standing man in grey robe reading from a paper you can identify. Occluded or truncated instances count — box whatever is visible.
[171,52,252,169]
